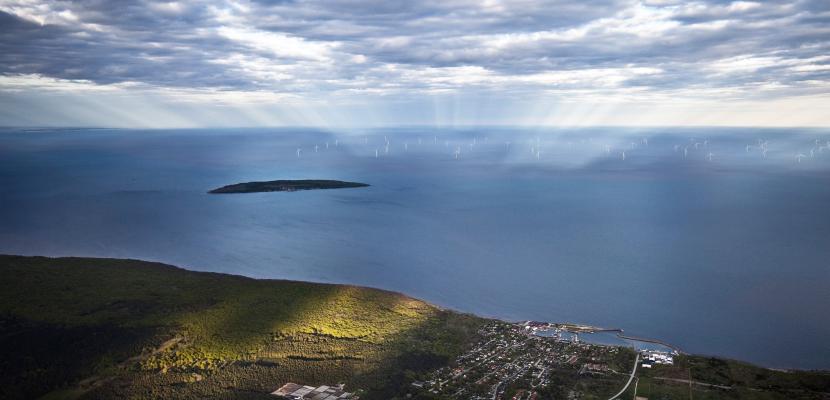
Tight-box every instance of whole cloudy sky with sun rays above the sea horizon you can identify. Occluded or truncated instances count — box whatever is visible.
[0,0,830,128]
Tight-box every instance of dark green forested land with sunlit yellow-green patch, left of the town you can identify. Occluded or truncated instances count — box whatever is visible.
[0,256,480,398]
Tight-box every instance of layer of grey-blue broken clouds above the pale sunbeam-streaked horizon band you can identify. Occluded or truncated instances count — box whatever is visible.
[0,0,830,99]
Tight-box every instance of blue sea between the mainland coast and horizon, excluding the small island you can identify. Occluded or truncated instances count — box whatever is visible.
[0,128,830,369]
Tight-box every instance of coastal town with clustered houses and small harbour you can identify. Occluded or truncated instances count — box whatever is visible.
[413,322,652,400]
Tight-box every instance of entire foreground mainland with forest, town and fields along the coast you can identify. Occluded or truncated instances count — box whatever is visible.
[0,255,830,400]
